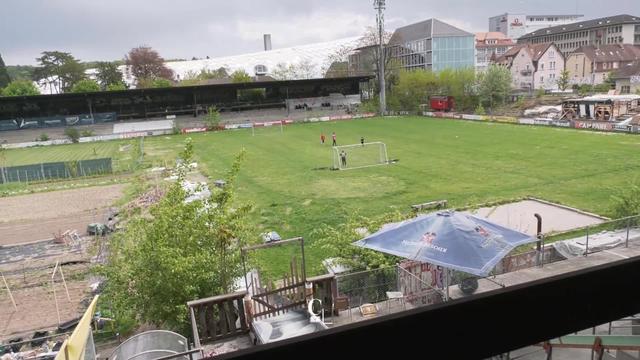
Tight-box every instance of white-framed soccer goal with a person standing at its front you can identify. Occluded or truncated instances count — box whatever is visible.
[333,142,389,170]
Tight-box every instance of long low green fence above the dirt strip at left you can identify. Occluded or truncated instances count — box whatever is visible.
[0,158,113,184]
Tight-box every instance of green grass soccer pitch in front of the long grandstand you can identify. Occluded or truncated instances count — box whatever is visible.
[6,117,640,272]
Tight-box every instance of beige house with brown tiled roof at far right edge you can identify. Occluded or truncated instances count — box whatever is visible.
[566,44,640,85]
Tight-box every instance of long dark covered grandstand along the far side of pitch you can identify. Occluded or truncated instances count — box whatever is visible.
[0,76,371,130]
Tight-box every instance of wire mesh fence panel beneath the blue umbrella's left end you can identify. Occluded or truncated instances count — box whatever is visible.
[336,267,398,306]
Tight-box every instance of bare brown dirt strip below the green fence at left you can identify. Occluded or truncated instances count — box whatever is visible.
[0,184,126,246]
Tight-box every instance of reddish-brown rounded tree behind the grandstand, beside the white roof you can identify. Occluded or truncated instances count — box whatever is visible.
[124,46,174,86]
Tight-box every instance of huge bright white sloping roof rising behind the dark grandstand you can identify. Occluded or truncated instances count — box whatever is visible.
[123,37,360,84]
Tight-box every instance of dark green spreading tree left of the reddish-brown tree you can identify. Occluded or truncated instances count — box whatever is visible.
[34,51,86,93]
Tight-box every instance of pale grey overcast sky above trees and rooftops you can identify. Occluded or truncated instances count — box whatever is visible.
[0,0,640,65]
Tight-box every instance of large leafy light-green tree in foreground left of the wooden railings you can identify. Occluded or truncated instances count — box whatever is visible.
[100,139,258,333]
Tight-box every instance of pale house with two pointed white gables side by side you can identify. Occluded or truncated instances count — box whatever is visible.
[494,43,565,90]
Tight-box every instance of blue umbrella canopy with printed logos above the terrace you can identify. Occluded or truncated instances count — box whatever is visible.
[354,211,537,276]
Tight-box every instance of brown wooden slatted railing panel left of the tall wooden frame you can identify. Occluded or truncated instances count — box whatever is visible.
[187,291,249,348]
